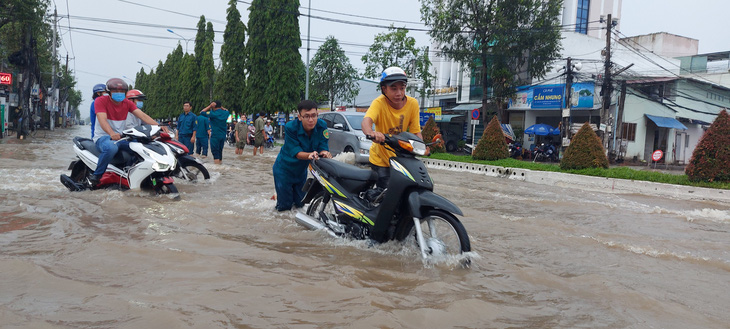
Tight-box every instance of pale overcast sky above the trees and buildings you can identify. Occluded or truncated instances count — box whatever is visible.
[58,0,730,118]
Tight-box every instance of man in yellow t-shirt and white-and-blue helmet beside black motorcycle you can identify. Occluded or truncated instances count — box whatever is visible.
[362,66,423,188]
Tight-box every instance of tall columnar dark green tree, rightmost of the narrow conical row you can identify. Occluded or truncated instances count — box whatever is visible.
[264,0,304,113]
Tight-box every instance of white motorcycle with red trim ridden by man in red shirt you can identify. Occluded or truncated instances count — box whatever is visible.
[60,125,180,198]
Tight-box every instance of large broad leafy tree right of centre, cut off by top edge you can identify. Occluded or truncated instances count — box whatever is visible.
[421,0,563,119]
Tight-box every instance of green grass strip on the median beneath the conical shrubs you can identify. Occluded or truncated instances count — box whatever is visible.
[430,153,730,190]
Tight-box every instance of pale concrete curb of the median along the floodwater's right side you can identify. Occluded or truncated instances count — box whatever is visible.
[421,158,730,202]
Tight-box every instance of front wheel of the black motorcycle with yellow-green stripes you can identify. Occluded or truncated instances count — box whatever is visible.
[409,209,471,257]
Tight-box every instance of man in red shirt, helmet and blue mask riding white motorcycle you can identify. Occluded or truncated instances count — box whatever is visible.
[88,78,161,187]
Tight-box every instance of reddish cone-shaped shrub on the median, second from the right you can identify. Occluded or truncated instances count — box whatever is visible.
[560,122,608,170]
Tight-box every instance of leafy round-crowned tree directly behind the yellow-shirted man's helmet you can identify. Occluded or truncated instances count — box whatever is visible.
[362,25,433,94]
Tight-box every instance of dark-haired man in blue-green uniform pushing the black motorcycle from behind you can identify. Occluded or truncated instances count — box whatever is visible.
[273,100,332,211]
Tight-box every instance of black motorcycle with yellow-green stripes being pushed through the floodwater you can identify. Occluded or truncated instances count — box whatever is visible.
[296,132,471,265]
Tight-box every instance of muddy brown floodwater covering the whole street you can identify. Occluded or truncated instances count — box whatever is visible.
[0,126,730,328]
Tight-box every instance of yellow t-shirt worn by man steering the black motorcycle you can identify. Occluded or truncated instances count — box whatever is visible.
[365,95,421,167]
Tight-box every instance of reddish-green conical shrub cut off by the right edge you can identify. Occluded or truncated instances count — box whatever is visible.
[685,110,730,182]
